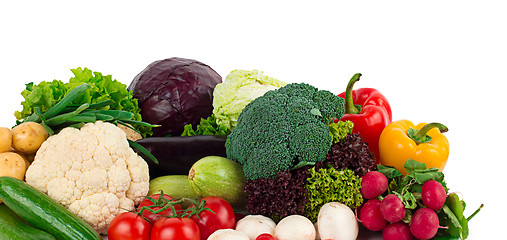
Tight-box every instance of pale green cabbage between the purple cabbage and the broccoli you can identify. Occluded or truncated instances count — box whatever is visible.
[213,70,287,130]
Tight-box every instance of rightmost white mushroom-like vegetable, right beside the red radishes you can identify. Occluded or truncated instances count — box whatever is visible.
[317,202,359,240]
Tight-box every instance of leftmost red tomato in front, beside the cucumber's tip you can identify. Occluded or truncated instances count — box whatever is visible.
[107,212,151,240]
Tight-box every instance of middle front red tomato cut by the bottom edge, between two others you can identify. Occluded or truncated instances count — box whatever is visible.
[151,217,201,240]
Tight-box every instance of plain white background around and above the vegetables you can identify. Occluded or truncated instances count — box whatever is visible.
[0,1,507,239]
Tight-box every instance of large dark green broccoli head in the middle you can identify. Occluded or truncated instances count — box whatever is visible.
[225,83,344,180]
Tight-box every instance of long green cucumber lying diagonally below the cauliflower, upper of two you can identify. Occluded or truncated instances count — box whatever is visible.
[0,177,101,240]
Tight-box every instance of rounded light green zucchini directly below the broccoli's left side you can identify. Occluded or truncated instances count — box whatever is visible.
[188,156,246,208]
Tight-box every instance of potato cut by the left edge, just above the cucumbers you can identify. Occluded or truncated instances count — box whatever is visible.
[0,152,27,203]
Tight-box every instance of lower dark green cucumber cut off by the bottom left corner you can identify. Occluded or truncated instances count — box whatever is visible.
[0,204,56,240]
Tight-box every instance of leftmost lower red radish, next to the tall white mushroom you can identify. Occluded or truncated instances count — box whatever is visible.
[359,199,387,231]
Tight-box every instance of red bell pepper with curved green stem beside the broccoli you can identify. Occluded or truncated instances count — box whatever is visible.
[335,73,393,164]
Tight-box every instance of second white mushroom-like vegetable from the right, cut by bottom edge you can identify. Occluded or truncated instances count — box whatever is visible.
[275,215,316,240]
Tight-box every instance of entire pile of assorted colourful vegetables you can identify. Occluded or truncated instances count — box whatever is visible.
[0,57,483,240]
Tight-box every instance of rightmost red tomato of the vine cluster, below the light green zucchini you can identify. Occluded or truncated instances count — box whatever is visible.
[190,196,236,239]
